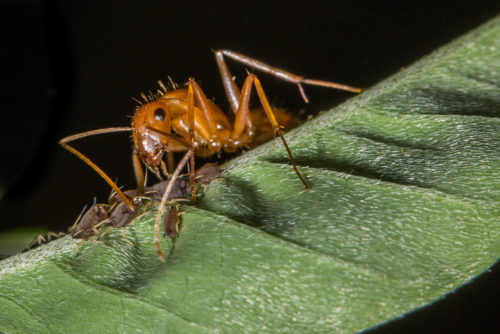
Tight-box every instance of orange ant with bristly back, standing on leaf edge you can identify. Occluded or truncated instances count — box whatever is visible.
[59,50,361,260]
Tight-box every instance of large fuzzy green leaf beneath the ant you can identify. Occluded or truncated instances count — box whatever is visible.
[0,14,500,333]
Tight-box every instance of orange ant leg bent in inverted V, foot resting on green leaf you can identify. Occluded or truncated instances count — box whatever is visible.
[233,73,309,190]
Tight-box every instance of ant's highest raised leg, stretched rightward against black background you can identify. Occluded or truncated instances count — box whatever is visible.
[214,50,361,104]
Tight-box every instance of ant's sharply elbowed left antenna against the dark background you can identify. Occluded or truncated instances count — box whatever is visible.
[59,127,135,211]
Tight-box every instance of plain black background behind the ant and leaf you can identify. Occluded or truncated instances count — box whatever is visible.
[0,0,500,333]
